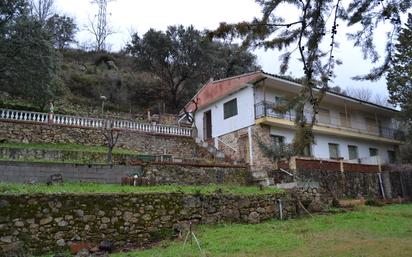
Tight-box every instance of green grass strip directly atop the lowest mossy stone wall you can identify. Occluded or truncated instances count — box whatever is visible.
[0,183,283,195]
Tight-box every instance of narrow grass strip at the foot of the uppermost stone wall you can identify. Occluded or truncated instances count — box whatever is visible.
[0,143,139,155]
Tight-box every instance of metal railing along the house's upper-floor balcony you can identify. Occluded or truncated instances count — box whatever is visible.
[255,102,404,140]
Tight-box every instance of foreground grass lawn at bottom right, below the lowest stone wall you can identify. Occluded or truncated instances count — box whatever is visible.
[110,204,412,257]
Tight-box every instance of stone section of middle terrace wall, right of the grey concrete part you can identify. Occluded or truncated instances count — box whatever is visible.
[143,163,252,185]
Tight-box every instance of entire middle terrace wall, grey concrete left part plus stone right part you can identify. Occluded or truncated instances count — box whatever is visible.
[0,161,251,185]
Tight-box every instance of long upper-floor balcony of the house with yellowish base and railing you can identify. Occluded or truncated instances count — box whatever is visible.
[255,101,404,143]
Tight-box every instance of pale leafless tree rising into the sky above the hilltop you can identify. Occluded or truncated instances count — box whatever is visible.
[87,0,114,51]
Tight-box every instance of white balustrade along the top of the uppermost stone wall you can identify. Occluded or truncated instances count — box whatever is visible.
[0,109,192,137]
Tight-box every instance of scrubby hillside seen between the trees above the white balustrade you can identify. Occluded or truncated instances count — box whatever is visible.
[0,50,158,116]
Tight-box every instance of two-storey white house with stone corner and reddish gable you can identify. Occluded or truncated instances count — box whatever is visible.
[186,71,402,172]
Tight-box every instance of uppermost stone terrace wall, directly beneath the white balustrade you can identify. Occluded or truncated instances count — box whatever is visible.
[0,121,213,158]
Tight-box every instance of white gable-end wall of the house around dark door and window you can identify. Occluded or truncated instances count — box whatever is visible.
[195,86,255,140]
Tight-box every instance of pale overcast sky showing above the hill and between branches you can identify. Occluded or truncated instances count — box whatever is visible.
[55,0,387,95]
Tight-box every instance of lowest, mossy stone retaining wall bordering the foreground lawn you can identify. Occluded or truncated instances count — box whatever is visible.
[0,189,324,256]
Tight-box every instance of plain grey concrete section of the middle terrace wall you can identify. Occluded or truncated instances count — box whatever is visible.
[0,161,141,184]
